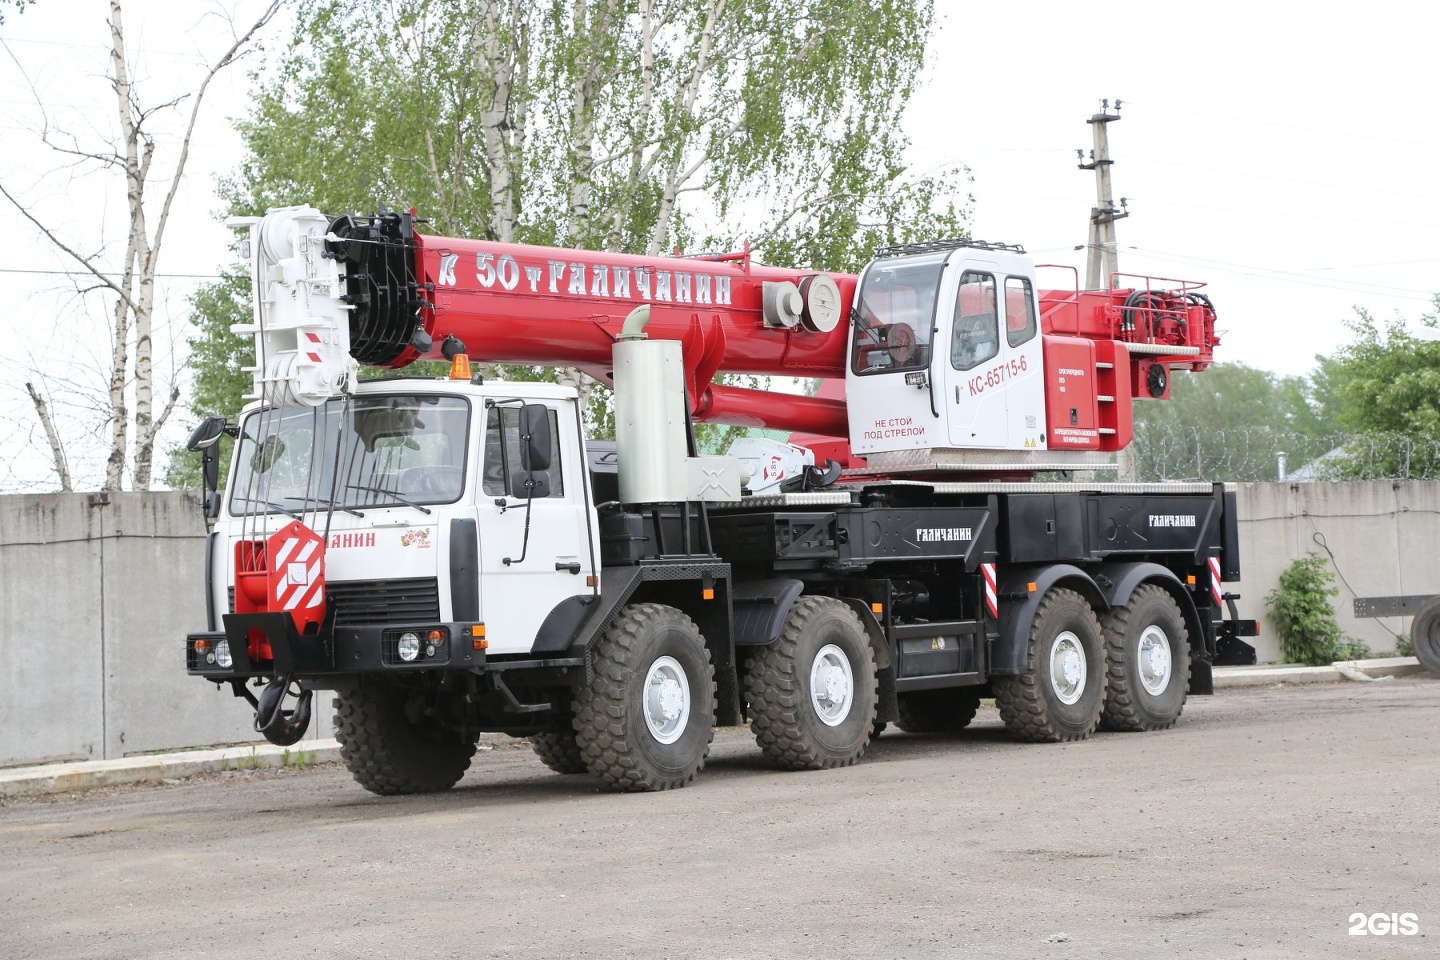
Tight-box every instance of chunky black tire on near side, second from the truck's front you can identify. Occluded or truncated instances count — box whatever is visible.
[744,597,878,770]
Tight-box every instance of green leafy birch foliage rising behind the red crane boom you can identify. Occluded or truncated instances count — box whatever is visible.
[177,0,969,454]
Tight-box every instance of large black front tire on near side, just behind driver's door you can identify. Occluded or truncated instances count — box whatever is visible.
[573,603,716,792]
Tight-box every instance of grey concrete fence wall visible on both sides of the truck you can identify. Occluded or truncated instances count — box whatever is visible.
[0,482,1440,766]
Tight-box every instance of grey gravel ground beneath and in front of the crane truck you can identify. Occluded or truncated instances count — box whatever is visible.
[0,676,1440,960]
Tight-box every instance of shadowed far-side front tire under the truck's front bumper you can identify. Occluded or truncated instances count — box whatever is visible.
[334,676,475,796]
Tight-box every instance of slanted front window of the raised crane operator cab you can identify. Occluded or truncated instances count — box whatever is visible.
[850,252,948,374]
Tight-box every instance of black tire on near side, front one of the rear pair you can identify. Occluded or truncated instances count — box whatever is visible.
[991,587,1104,743]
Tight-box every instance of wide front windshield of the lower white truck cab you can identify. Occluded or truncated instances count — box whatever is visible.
[230,393,469,514]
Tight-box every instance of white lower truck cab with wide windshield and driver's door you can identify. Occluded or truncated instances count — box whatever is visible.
[212,379,599,662]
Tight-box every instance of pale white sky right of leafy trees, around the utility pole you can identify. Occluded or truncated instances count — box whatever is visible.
[907,0,1440,376]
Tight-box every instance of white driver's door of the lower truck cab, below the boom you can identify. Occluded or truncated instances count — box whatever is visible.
[478,403,596,653]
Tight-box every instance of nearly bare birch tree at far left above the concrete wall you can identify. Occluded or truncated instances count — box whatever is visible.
[0,0,279,491]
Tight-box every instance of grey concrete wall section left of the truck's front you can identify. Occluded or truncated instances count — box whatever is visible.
[0,494,330,766]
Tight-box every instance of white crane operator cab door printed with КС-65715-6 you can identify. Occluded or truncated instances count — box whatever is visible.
[937,269,1044,449]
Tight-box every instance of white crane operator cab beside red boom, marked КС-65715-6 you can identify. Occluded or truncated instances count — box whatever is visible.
[845,240,1045,456]
